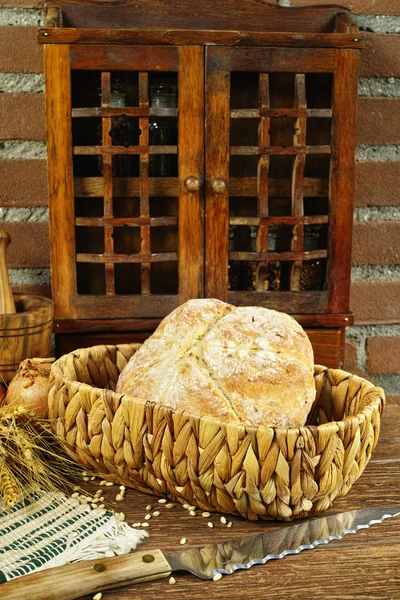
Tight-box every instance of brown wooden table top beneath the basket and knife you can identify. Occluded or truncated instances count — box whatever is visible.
[67,400,400,600]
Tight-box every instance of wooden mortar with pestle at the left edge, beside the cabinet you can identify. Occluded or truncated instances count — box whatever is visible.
[0,231,54,383]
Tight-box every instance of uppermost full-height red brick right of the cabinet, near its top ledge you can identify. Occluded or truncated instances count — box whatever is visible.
[360,34,400,77]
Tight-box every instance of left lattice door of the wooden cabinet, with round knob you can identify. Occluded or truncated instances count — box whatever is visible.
[45,45,204,319]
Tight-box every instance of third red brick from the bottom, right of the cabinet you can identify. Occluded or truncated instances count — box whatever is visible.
[352,221,400,265]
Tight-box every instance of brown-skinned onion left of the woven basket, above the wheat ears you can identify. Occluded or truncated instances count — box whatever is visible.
[6,358,54,418]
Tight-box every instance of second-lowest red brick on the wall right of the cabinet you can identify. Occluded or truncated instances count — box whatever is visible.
[350,281,400,325]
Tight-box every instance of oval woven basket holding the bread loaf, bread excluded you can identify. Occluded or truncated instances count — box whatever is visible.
[49,344,385,521]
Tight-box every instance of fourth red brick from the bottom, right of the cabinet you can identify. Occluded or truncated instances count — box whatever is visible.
[354,162,400,206]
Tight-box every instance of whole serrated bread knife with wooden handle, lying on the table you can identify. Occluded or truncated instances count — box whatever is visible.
[0,506,400,600]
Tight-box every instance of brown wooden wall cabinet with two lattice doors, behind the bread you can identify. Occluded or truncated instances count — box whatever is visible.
[39,0,362,366]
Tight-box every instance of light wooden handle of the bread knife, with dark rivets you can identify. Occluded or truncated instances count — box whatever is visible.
[0,550,171,600]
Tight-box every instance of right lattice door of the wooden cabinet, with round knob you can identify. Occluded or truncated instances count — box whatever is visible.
[205,47,357,314]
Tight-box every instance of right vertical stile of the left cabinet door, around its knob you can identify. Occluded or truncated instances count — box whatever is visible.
[178,46,204,303]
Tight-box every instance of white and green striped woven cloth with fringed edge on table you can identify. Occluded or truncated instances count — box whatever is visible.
[0,492,148,584]
